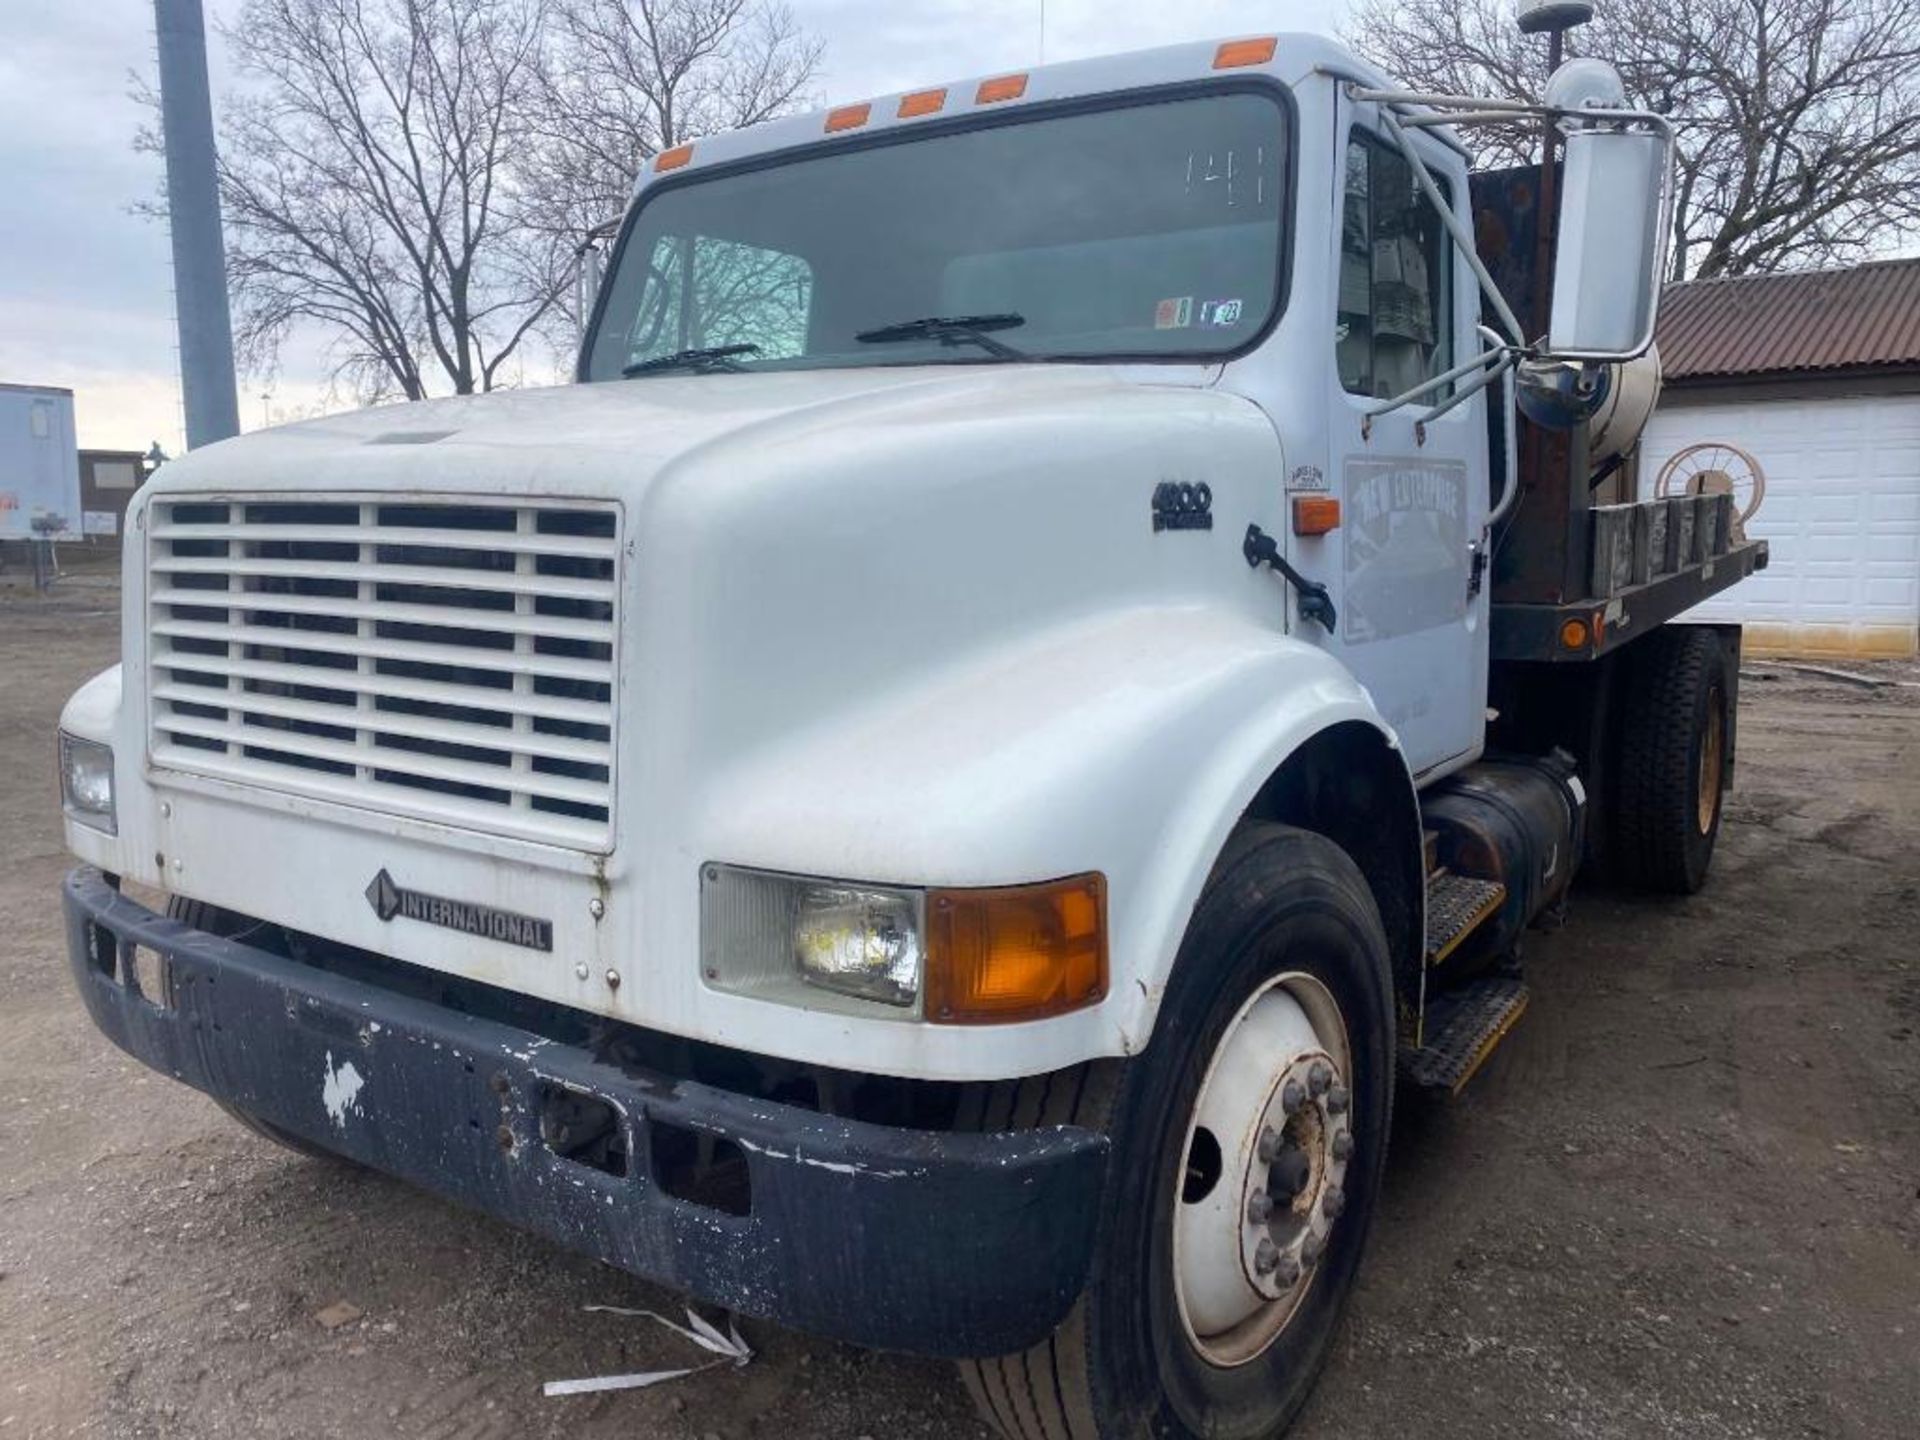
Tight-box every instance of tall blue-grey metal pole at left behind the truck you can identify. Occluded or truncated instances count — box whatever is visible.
[154,0,240,449]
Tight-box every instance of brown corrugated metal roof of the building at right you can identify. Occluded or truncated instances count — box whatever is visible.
[1657,259,1920,380]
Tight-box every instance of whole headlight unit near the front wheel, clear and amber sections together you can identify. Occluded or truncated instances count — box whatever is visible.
[701,866,1108,1025]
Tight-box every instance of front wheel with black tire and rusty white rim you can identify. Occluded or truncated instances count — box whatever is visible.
[962,826,1394,1440]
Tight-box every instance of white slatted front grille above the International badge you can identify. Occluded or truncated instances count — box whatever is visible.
[148,497,620,849]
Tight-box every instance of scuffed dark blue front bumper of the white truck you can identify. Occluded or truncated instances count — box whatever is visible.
[63,870,1106,1356]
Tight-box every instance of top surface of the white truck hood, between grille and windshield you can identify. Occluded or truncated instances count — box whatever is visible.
[150,365,1175,499]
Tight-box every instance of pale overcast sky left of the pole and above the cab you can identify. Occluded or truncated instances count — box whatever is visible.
[0,0,1344,453]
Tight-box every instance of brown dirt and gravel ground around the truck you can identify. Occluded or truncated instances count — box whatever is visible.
[0,588,1920,1440]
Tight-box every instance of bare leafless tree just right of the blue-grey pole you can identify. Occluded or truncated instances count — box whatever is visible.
[221,0,566,399]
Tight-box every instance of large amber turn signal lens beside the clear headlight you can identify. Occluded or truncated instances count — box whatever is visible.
[925,876,1106,1025]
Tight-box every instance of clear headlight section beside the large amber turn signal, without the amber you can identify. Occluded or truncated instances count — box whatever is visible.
[701,866,925,1014]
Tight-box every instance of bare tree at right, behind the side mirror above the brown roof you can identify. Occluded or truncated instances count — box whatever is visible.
[1354,0,1920,278]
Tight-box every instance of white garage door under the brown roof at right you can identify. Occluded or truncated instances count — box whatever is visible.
[1640,396,1920,657]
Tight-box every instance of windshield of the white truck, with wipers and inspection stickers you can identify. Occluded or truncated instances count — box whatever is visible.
[586,90,1286,380]
